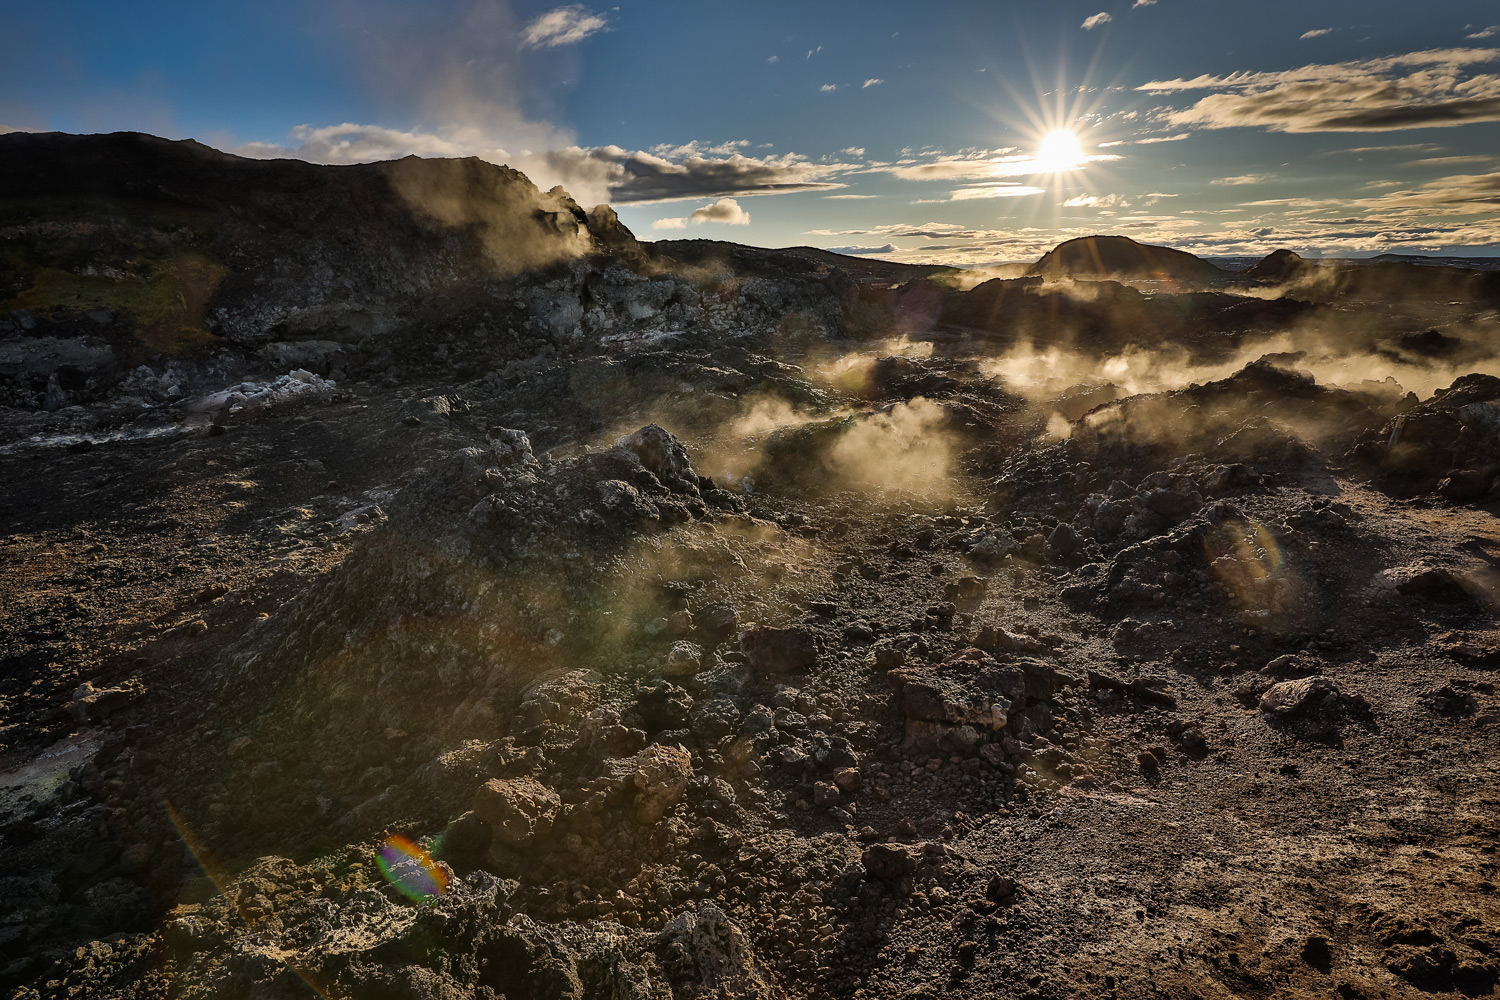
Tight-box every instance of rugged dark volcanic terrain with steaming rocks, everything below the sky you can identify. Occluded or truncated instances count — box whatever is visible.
[0,135,1500,1000]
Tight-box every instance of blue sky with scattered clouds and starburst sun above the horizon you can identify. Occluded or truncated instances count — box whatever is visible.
[0,0,1500,264]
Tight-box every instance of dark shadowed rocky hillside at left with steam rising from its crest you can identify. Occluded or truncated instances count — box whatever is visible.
[0,132,635,345]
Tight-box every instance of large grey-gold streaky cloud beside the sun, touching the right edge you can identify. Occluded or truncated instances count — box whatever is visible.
[1137,48,1500,132]
